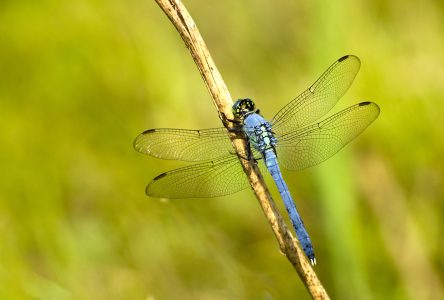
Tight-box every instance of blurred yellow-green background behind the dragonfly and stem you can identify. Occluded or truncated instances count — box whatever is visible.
[0,0,444,300]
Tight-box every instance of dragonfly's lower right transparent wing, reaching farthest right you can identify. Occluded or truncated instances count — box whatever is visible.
[276,102,379,170]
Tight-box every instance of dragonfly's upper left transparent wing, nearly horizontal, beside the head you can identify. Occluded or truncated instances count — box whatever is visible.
[134,127,234,161]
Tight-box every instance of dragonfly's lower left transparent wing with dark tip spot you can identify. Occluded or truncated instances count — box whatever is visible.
[146,155,265,199]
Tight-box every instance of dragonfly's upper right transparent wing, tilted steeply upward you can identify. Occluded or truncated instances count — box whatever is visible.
[271,55,361,134]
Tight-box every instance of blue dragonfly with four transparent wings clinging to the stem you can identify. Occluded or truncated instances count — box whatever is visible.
[134,55,380,265]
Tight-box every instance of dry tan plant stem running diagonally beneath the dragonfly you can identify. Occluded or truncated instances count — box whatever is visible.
[156,0,329,299]
